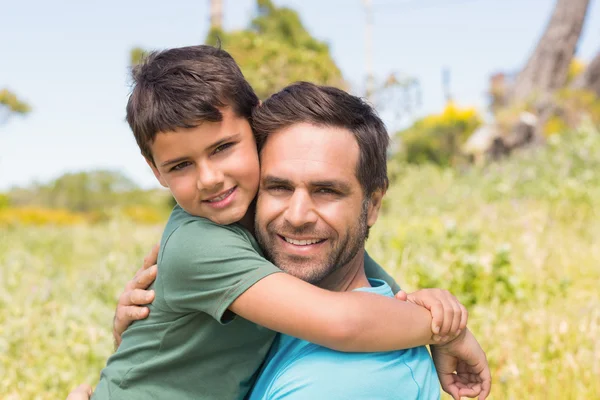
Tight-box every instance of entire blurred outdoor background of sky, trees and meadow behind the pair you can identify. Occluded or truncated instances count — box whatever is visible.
[0,0,600,399]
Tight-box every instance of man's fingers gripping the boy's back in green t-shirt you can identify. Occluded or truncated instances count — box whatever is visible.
[113,244,158,348]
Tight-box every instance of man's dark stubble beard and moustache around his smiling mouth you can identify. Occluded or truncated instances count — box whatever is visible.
[255,199,370,284]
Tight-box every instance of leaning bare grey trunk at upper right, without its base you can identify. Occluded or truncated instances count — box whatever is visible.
[512,0,590,101]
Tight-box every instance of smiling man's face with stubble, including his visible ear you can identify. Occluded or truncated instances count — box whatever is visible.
[256,123,381,283]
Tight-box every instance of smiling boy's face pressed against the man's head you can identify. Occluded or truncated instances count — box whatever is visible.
[146,107,260,225]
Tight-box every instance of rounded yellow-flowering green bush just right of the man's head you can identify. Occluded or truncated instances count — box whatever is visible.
[395,103,482,166]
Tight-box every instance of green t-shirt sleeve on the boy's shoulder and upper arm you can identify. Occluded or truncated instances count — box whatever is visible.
[157,221,281,322]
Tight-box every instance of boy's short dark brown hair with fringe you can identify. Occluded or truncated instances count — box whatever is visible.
[127,45,259,162]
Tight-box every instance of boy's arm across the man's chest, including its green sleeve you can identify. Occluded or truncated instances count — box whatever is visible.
[156,221,435,352]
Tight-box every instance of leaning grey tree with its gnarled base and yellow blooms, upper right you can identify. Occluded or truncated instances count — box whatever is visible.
[468,0,597,159]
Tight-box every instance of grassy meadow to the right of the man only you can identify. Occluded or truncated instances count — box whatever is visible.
[367,127,600,399]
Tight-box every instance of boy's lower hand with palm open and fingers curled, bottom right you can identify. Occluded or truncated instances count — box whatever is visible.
[430,329,492,400]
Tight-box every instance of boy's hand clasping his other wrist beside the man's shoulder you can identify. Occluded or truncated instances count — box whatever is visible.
[396,289,468,343]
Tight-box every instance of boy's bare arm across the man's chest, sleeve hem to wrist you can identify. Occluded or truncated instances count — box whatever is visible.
[229,273,435,352]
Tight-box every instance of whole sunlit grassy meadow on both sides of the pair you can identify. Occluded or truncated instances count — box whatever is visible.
[0,129,600,399]
